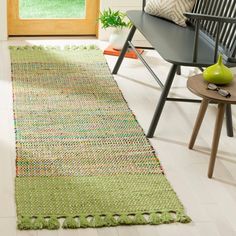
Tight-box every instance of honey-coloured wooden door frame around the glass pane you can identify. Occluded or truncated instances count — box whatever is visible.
[8,0,99,36]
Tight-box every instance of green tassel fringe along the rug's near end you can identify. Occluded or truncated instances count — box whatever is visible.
[17,211,191,230]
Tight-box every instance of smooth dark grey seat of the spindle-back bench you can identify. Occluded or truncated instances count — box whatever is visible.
[127,10,228,67]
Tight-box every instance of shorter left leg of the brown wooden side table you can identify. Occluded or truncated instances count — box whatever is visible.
[188,98,209,149]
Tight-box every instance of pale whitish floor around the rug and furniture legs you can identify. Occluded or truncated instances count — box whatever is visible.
[0,38,236,236]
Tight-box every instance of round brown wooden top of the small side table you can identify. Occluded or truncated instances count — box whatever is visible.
[187,74,236,104]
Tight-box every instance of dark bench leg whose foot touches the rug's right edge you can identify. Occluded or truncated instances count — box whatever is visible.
[147,64,178,138]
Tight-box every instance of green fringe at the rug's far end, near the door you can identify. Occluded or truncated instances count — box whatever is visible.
[8,45,99,51]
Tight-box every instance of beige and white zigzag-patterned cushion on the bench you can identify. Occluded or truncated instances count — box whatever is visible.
[144,0,196,27]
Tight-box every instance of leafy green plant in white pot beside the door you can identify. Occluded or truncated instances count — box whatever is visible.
[98,8,131,29]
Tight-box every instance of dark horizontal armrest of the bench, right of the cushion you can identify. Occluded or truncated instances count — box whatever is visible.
[184,12,236,24]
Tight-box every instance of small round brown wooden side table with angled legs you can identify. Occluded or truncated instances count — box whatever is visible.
[187,74,236,178]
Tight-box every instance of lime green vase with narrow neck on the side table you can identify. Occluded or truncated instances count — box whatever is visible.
[203,55,234,84]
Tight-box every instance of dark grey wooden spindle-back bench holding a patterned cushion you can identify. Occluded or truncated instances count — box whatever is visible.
[113,0,236,138]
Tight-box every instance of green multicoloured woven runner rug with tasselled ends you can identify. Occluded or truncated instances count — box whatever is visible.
[10,46,190,229]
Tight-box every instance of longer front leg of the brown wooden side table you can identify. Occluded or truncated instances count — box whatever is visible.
[208,103,226,178]
